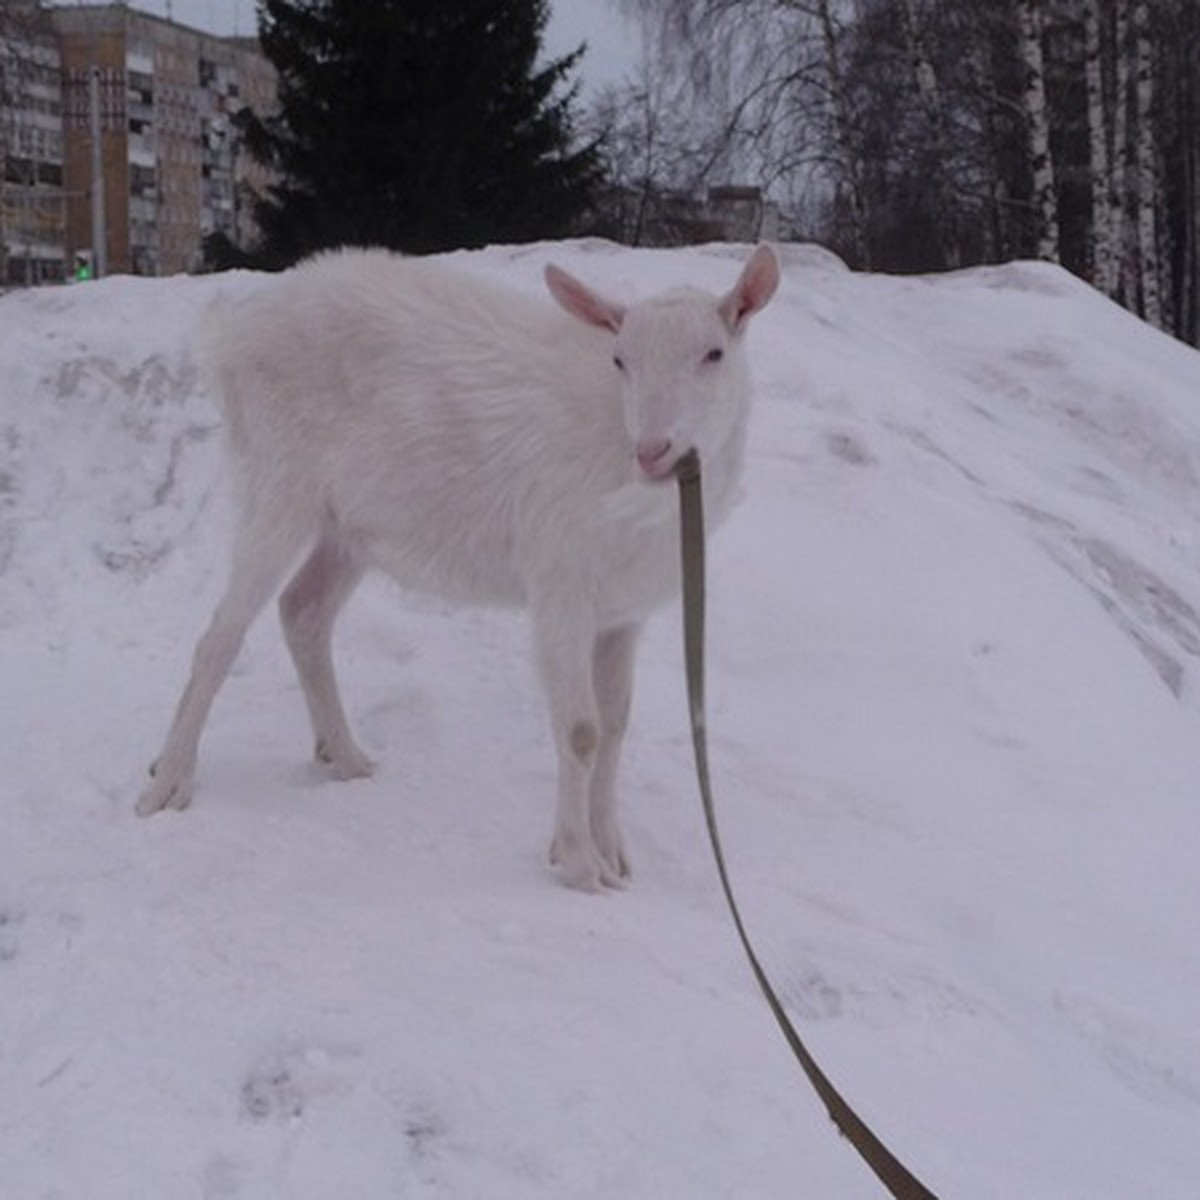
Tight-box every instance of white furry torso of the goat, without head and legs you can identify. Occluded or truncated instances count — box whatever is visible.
[206,251,648,604]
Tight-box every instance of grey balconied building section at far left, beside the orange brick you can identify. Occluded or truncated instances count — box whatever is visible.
[0,0,67,287]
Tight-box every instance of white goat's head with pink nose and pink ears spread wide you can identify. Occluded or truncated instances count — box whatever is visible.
[546,245,779,481]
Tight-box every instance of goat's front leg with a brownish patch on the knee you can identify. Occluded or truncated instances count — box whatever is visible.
[533,594,622,892]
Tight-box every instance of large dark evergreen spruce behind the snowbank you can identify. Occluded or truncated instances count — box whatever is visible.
[224,0,599,268]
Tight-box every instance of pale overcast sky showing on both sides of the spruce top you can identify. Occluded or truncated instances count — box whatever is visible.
[123,0,638,90]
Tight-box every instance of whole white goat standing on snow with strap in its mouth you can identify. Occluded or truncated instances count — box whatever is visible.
[138,246,779,890]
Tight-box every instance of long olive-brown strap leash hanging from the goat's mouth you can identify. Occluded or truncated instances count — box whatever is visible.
[676,451,937,1200]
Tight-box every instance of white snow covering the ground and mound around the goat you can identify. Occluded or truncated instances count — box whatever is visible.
[0,242,1200,1200]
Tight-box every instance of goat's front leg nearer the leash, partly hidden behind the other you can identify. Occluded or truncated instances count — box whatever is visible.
[589,625,641,878]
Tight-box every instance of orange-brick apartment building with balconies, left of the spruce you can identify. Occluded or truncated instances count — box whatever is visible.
[0,0,276,283]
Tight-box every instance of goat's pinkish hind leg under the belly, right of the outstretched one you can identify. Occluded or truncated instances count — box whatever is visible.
[280,526,374,779]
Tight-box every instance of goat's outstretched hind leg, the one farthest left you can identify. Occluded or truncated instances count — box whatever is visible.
[137,510,304,816]
